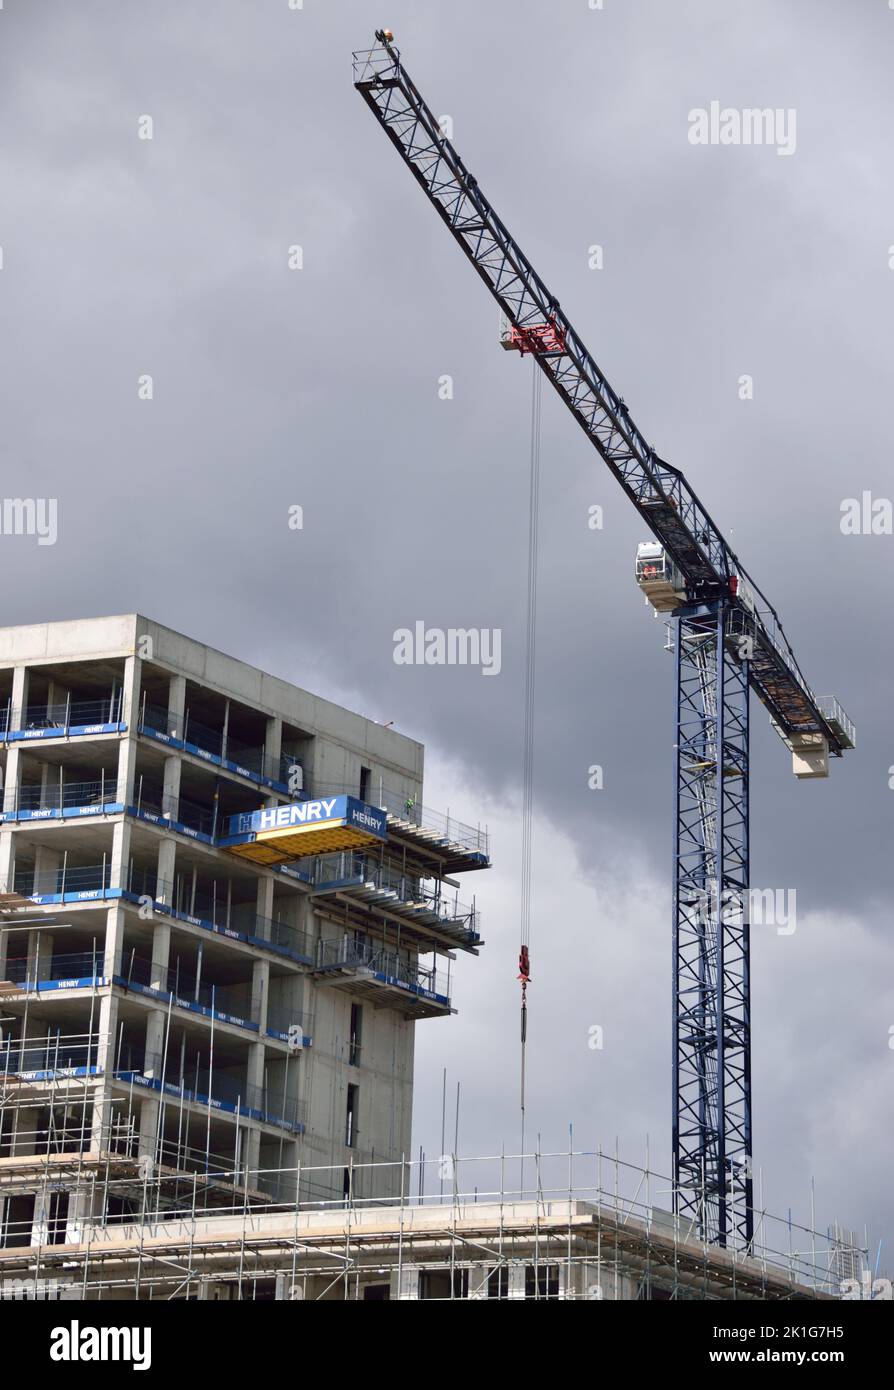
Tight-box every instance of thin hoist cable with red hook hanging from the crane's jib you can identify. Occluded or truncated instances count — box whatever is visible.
[519,356,542,1128]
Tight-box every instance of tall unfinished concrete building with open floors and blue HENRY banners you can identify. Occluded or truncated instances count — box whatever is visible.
[0,616,488,1284]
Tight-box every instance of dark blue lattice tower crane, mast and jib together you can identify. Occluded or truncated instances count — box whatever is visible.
[353,29,855,1250]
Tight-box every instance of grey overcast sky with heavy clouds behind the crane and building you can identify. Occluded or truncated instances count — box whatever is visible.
[0,0,894,1266]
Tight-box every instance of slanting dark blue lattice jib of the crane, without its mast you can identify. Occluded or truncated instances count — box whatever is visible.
[355,33,854,755]
